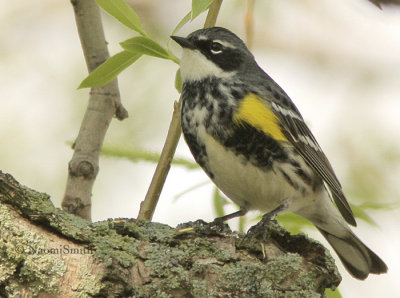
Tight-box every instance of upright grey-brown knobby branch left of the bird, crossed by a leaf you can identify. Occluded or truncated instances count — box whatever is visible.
[62,0,128,220]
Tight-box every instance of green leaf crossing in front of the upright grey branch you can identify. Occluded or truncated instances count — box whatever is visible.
[78,51,141,89]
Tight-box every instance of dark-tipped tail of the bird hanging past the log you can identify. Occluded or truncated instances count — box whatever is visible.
[317,225,387,279]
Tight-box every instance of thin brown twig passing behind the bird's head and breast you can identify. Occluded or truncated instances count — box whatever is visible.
[138,0,222,220]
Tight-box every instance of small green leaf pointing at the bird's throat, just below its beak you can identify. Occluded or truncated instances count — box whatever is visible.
[121,36,179,64]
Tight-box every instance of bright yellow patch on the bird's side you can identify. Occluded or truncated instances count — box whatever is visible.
[233,93,287,141]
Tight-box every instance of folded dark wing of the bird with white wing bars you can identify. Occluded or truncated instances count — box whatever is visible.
[264,94,356,226]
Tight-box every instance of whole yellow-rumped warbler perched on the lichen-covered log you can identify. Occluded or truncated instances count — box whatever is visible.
[171,27,387,279]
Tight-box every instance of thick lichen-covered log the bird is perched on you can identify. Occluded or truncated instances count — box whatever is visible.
[0,172,340,297]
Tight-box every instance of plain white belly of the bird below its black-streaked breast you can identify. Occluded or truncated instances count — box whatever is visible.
[198,126,299,212]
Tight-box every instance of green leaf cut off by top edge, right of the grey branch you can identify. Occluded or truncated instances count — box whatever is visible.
[95,0,147,36]
